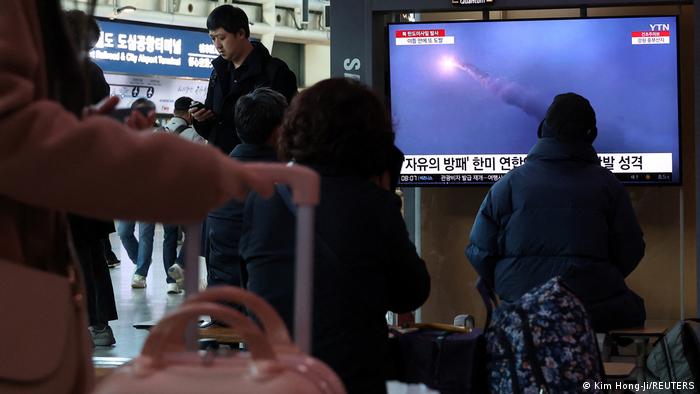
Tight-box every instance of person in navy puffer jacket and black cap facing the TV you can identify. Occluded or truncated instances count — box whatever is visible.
[466,93,646,332]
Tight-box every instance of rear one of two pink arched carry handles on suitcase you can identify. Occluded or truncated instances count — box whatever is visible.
[184,286,294,347]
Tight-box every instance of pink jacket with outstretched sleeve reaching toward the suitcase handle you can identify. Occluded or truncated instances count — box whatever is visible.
[0,0,258,272]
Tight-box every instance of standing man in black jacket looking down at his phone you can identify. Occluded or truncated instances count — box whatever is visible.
[192,5,297,154]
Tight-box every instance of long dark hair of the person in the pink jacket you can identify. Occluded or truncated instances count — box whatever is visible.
[35,0,95,116]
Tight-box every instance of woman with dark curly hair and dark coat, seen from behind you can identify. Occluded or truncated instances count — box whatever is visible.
[240,79,430,393]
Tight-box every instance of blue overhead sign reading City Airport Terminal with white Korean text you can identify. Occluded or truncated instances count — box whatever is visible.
[90,20,218,79]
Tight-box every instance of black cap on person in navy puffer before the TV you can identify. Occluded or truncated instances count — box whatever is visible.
[538,93,598,143]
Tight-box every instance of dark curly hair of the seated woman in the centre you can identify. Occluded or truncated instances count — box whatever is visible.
[279,78,395,177]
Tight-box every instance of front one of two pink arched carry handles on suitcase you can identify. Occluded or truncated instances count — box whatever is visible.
[137,301,277,368]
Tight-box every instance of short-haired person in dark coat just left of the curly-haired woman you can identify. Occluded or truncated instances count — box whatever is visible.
[206,88,287,286]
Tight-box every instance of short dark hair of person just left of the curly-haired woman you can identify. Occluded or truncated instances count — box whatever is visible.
[235,88,287,145]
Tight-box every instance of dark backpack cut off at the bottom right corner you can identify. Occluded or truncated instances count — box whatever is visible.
[643,319,700,393]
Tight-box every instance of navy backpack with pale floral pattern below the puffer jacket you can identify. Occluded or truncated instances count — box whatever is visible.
[486,277,604,394]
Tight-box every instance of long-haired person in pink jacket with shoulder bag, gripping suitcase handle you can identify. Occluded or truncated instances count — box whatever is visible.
[0,0,271,393]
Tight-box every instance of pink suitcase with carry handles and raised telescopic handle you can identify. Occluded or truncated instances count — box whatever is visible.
[96,164,345,394]
